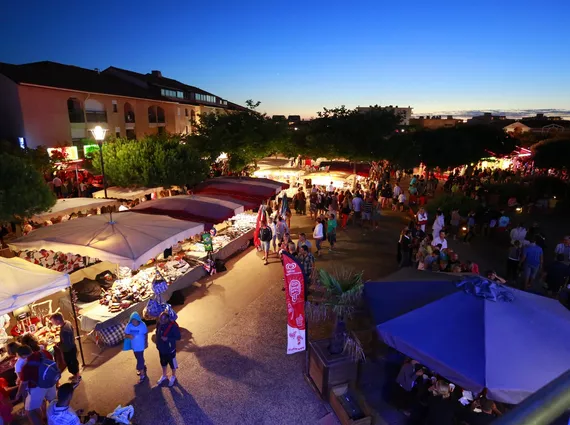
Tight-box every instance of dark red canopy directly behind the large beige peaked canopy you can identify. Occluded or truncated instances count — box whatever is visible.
[131,195,245,224]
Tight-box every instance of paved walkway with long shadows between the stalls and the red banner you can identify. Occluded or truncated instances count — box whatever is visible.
[64,210,400,425]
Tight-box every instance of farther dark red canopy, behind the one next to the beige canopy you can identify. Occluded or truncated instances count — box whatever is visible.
[194,177,289,202]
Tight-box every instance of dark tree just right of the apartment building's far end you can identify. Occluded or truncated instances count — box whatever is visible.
[186,100,289,172]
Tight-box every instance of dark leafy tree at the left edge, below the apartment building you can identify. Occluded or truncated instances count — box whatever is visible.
[0,153,56,222]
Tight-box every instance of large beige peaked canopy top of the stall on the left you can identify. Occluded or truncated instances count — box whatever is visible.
[9,212,204,270]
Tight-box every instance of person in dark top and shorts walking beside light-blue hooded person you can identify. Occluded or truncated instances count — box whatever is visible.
[156,311,181,387]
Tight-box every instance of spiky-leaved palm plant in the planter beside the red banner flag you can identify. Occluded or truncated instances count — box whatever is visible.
[306,268,364,360]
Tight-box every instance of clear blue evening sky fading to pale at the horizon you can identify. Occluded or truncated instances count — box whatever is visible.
[0,0,570,117]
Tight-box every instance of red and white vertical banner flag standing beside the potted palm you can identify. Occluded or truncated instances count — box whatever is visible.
[283,252,307,354]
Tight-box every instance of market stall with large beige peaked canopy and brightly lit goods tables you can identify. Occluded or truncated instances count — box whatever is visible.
[10,211,255,332]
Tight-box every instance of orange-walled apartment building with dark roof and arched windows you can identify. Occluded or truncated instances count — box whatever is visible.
[0,62,243,152]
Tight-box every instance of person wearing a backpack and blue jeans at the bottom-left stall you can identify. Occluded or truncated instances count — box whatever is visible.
[18,345,61,425]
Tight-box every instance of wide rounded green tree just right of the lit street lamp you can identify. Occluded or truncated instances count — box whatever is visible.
[93,135,208,187]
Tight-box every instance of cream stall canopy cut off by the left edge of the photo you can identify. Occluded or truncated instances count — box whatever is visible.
[0,257,71,315]
